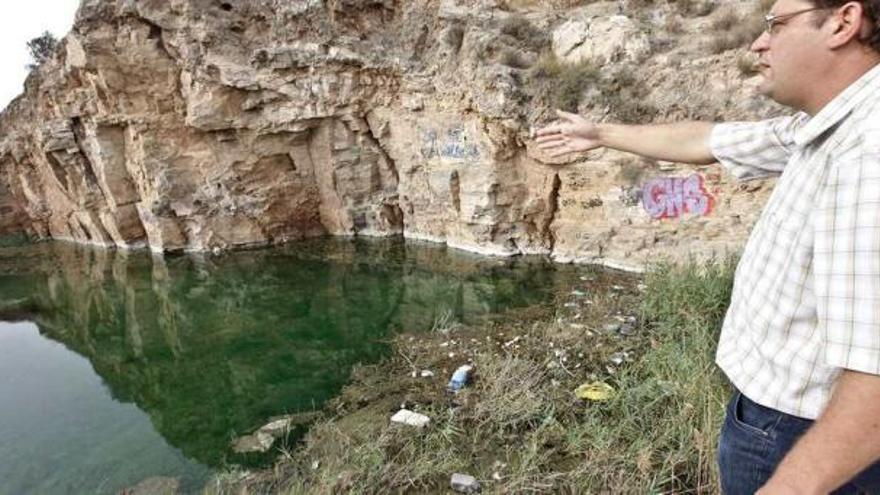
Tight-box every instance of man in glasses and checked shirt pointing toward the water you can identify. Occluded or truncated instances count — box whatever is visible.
[537,0,880,495]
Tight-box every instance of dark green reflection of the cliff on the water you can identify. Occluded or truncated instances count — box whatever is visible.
[0,239,571,474]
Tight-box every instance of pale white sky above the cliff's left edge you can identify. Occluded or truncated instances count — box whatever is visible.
[0,0,79,109]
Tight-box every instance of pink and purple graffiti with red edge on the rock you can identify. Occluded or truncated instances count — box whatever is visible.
[642,174,714,219]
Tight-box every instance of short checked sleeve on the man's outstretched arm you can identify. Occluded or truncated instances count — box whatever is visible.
[709,113,808,180]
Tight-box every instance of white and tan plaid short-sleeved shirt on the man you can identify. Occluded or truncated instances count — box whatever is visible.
[710,61,880,419]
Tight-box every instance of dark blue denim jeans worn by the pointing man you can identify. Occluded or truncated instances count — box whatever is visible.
[718,391,880,495]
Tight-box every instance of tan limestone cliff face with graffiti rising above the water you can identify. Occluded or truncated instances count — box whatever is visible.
[0,0,770,265]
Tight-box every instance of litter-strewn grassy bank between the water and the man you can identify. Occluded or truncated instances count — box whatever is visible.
[218,262,734,494]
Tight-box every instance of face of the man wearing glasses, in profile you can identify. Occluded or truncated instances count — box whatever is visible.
[750,0,825,109]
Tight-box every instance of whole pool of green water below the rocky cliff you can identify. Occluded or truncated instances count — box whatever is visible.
[0,239,573,495]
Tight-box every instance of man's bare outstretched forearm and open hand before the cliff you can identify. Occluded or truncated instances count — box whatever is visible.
[537,110,716,164]
